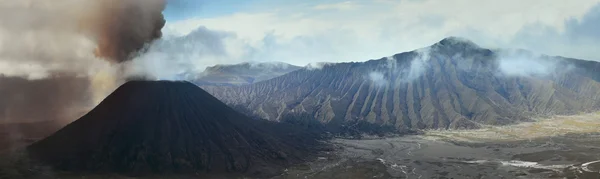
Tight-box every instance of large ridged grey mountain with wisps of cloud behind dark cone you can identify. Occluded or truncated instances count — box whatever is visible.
[205,38,600,129]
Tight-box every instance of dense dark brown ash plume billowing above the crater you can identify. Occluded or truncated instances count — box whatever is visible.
[83,0,166,62]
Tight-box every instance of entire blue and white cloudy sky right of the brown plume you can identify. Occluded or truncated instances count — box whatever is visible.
[156,0,600,70]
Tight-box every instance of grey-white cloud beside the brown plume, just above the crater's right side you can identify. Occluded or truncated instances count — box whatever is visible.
[124,28,241,80]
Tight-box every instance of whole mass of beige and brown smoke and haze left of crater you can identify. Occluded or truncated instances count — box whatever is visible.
[0,0,166,129]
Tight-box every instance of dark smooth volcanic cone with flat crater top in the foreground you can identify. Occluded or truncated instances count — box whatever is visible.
[27,81,319,176]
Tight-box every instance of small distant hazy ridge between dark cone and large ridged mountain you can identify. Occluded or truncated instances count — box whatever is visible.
[195,62,300,85]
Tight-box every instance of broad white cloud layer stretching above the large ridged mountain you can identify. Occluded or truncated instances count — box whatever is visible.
[164,0,600,72]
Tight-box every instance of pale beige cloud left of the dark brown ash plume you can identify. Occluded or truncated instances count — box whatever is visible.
[0,0,100,79]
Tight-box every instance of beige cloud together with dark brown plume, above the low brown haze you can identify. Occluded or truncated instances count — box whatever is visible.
[0,0,165,76]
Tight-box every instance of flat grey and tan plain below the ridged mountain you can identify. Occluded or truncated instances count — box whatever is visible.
[279,113,600,179]
